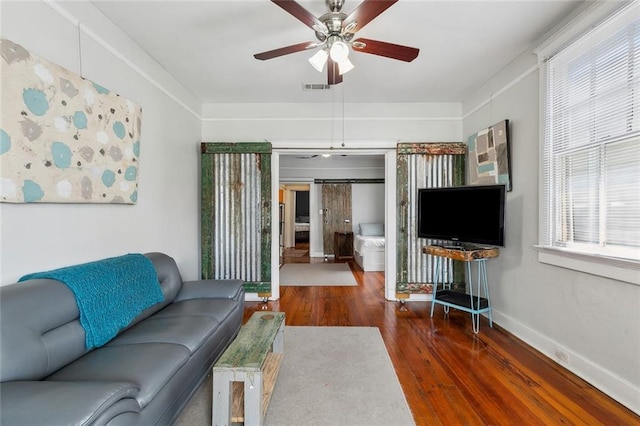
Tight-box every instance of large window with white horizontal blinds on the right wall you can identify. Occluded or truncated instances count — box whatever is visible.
[540,2,640,270]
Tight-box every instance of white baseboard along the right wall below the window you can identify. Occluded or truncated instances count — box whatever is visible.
[491,309,640,415]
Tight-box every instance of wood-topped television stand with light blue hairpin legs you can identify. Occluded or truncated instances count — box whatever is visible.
[422,246,500,334]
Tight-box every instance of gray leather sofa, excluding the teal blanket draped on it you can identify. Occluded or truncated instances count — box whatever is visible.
[0,253,244,426]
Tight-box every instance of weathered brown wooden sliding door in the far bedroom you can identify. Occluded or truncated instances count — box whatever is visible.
[322,183,352,255]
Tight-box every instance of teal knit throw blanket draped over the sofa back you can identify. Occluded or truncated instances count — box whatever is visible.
[19,254,164,349]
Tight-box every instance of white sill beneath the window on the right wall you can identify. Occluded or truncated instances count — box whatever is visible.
[534,246,640,285]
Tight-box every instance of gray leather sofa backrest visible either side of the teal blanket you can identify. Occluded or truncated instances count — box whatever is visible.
[0,253,182,382]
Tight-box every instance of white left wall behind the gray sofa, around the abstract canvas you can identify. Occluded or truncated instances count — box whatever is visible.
[0,1,201,285]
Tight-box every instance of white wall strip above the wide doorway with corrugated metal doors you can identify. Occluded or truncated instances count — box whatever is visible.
[202,100,462,143]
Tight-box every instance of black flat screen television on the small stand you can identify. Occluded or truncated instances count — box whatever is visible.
[418,185,505,246]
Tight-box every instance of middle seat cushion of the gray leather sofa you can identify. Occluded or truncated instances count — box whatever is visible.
[108,315,220,353]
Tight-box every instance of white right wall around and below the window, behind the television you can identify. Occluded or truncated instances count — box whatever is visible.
[463,45,640,412]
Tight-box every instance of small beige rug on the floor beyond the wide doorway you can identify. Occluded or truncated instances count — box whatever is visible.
[280,263,358,286]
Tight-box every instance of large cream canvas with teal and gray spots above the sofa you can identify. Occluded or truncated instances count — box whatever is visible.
[0,39,142,204]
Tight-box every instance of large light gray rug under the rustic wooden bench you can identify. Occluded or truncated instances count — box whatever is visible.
[175,327,415,426]
